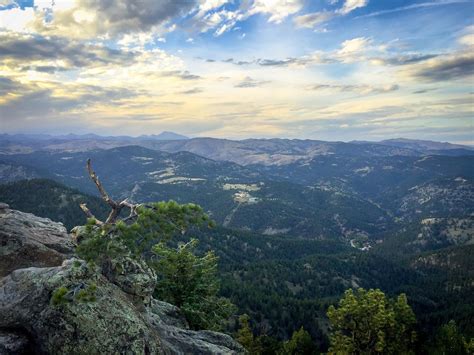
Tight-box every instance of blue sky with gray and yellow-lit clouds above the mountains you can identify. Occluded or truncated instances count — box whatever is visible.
[0,0,474,144]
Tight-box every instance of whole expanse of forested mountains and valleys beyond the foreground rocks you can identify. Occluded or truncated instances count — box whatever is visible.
[0,135,474,347]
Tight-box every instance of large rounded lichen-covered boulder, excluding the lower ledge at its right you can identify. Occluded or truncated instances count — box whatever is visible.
[0,259,163,354]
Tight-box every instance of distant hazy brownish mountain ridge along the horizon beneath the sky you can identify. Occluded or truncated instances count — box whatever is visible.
[0,132,474,161]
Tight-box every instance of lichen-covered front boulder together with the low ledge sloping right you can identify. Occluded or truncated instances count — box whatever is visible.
[0,259,243,354]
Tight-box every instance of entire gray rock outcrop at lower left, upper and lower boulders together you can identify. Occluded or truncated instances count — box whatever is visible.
[0,209,245,355]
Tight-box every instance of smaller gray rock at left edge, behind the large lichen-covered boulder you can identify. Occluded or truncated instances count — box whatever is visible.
[0,203,73,277]
